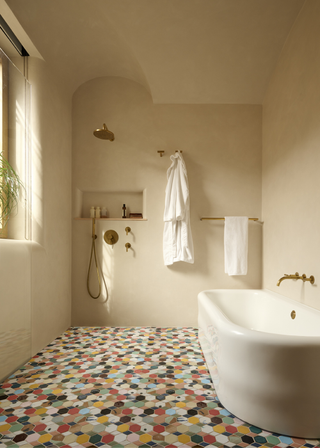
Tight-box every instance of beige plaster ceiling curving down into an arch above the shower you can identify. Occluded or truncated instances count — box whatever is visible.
[0,0,305,104]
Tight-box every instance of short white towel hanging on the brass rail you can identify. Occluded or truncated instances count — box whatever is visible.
[224,216,249,275]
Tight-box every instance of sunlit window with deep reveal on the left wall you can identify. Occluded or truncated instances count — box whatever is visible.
[0,49,31,240]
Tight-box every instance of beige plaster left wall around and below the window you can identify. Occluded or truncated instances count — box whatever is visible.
[0,58,71,380]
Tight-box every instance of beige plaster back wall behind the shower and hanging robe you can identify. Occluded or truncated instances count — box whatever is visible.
[72,77,262,326]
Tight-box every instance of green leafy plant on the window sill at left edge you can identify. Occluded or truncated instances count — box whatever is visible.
[0,152,24,229]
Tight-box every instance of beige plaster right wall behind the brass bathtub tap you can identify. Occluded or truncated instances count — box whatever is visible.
[262,0,320,309]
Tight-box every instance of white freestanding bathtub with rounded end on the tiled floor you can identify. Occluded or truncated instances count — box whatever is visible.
[198,289,320,438]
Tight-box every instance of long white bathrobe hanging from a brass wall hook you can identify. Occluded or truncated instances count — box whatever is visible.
[163,152,194,266]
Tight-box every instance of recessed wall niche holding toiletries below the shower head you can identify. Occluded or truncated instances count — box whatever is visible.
[74,188,148,222]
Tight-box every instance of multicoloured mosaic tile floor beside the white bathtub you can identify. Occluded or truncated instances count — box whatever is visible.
[0,327,320,448]
